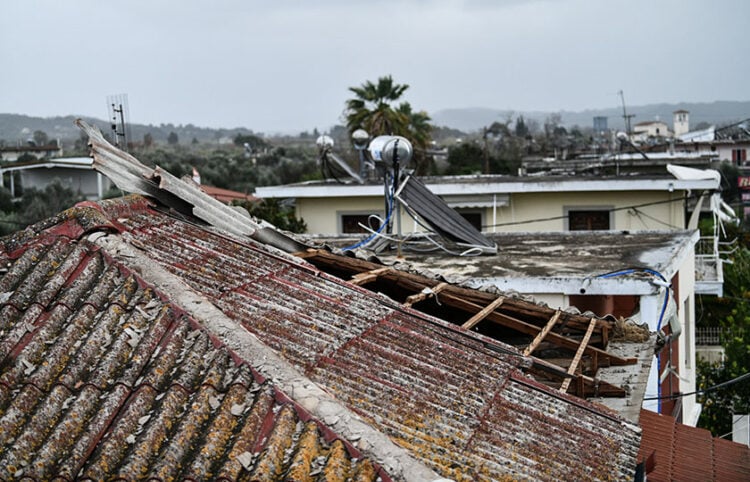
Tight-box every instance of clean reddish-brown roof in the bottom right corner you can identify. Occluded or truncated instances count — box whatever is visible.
[638,410,750,482]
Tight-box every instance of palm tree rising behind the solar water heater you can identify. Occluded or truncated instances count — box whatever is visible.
[344,75,432,174]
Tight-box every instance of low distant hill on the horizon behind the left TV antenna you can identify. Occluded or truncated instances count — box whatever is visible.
[0,114,253,145]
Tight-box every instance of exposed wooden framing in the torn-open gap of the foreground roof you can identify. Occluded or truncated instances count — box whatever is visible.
[296,249,636,397]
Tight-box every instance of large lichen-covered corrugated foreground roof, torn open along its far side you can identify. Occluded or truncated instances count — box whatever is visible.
[0,119,640,481]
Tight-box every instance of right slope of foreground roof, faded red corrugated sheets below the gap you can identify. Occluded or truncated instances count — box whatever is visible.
[54,194,640,481]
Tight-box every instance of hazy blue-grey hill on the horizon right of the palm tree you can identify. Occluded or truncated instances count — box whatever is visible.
[430,101,750,132]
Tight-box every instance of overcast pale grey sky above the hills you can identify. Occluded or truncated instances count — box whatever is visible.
[0,0,750,133]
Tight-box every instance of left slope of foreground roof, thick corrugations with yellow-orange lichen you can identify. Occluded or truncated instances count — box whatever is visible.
[0,234,389,481]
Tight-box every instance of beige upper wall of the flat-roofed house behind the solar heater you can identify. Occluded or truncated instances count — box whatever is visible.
[296,191,685,234]
